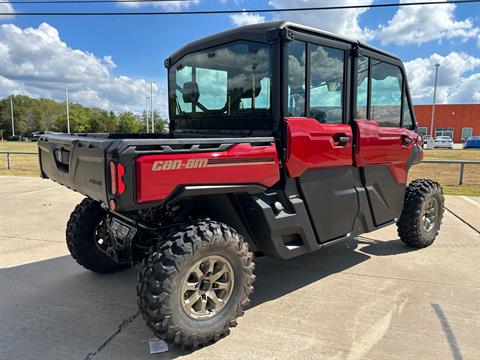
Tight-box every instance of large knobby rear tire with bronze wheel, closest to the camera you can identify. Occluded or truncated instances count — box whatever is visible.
[137,221,255,349]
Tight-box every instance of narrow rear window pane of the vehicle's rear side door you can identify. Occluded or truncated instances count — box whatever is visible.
[288,41,306,117]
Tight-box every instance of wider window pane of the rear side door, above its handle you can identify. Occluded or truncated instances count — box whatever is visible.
[308,44,345,124]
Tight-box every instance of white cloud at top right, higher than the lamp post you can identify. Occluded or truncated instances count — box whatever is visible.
[378,0,480,45]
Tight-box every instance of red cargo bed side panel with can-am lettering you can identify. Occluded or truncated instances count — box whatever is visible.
[136,144,280,203]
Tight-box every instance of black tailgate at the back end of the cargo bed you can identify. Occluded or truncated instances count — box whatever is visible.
[38,134,112,201]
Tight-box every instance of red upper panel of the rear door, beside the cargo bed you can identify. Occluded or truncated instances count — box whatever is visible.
[285,118,353,177]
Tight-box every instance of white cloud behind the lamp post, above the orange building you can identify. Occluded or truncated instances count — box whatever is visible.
[405,51,480,104]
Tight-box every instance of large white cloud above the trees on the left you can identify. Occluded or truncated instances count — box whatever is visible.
[0,23,167,114]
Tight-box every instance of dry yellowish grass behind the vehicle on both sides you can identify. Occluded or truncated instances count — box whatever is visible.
[0,141,480,196]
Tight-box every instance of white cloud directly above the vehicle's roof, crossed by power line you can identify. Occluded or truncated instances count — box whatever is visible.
[269,0,375,40]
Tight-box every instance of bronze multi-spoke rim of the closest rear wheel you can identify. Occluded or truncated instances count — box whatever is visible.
[180,256,234,320]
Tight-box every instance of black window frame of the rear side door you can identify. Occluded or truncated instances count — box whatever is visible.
[282,31,352,125]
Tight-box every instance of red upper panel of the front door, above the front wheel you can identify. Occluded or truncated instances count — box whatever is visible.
[355,120,418,184]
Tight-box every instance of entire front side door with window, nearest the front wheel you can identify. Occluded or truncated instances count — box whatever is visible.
[354,54,417,225]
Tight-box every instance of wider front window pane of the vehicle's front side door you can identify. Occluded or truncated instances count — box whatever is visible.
[371,59,402,127]
